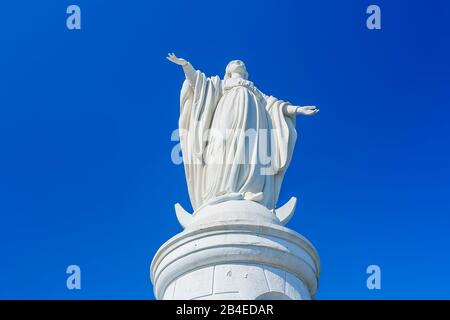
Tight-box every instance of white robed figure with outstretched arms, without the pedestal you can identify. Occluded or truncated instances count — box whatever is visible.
[167,53,319,210]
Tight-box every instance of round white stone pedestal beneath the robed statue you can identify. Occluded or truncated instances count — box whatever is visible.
[151,200,320,300]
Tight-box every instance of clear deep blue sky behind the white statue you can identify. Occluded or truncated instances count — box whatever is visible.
[0,0,450,299]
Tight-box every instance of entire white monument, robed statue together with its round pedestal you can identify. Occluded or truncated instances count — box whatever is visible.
[151,54,320,300]
